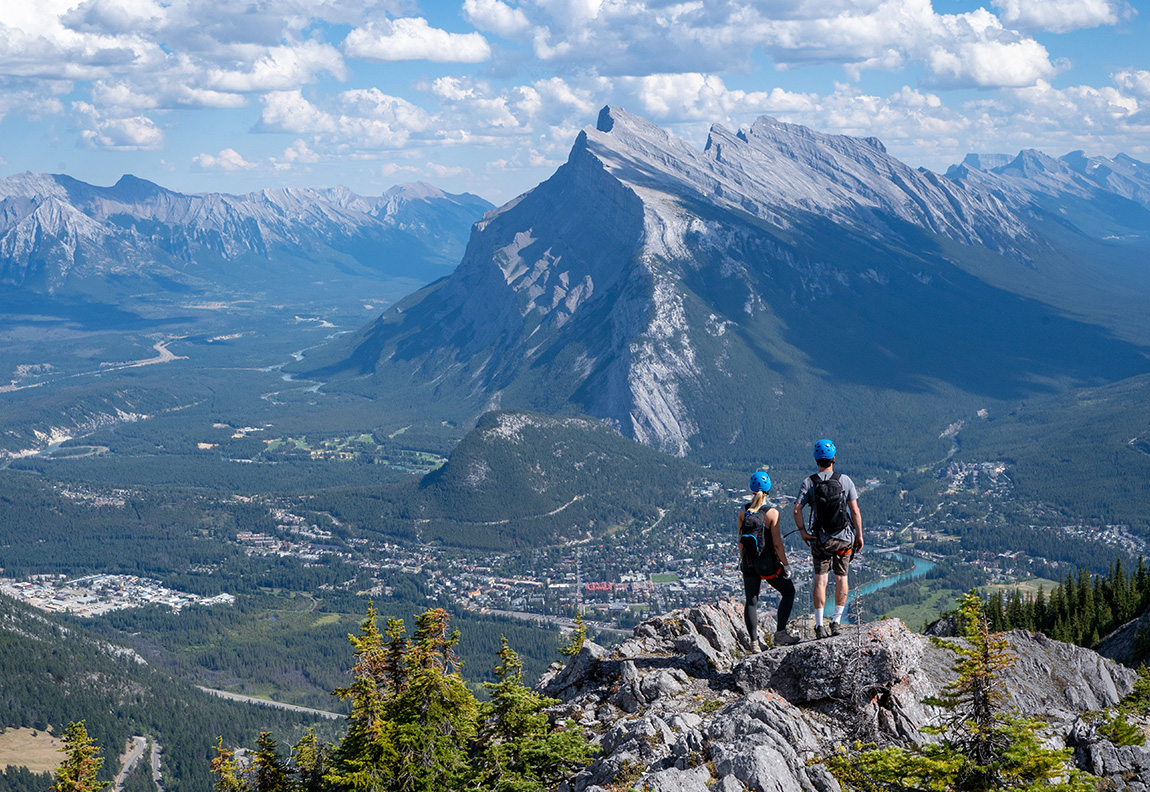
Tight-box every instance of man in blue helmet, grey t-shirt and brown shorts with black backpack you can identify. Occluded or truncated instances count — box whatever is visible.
[794,440,863,638]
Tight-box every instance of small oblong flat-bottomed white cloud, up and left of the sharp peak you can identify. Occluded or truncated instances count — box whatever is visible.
[335,17,491,63]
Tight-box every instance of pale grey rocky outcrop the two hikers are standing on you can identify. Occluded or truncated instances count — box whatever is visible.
[539,601,1150,792]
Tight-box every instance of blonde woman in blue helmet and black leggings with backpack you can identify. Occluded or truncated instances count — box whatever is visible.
[738,470,798,652]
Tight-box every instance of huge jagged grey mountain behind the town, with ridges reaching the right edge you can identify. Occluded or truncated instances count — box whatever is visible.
[299,101,1150,464]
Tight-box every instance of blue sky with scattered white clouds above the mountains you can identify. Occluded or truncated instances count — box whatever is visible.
[0,0,1150,203]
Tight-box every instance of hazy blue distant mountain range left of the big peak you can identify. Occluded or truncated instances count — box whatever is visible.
[0,174,491,298]
